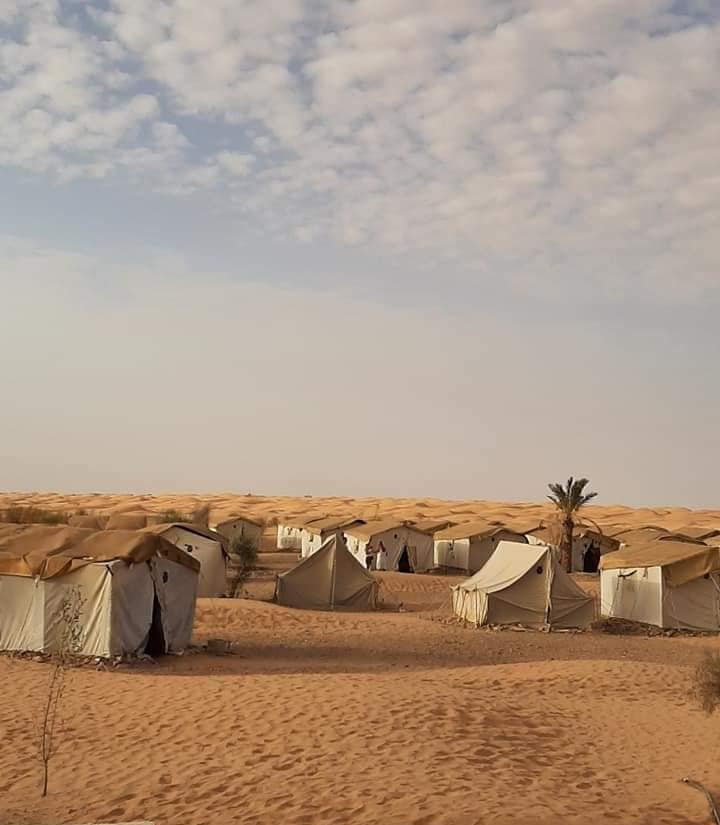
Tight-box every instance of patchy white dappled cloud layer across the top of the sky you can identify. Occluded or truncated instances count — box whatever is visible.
[0,0,720,303]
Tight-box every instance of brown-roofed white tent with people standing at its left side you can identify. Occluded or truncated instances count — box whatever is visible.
[344,519,434,573]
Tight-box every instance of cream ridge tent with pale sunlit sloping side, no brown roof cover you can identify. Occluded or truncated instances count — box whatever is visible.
[452,541,594,627]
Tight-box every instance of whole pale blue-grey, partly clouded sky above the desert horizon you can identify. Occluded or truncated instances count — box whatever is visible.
[0,0,720,507]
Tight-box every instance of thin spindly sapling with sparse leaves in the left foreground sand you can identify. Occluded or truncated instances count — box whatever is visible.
[36,588,85,796]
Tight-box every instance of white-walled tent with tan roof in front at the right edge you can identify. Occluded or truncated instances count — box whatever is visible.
[600,539,720,630]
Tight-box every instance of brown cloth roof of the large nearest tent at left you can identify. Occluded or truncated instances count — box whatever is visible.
[0,524,200,579]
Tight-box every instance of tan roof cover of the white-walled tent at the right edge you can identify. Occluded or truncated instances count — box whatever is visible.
[600,540,720,587]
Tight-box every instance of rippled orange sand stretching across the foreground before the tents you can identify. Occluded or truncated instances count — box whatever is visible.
[0,558,720,825]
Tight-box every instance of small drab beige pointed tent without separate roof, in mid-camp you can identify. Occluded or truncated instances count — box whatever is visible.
[275,535,378,610]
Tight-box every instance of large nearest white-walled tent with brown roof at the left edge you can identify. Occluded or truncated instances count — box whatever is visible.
[0,525,200,657]
